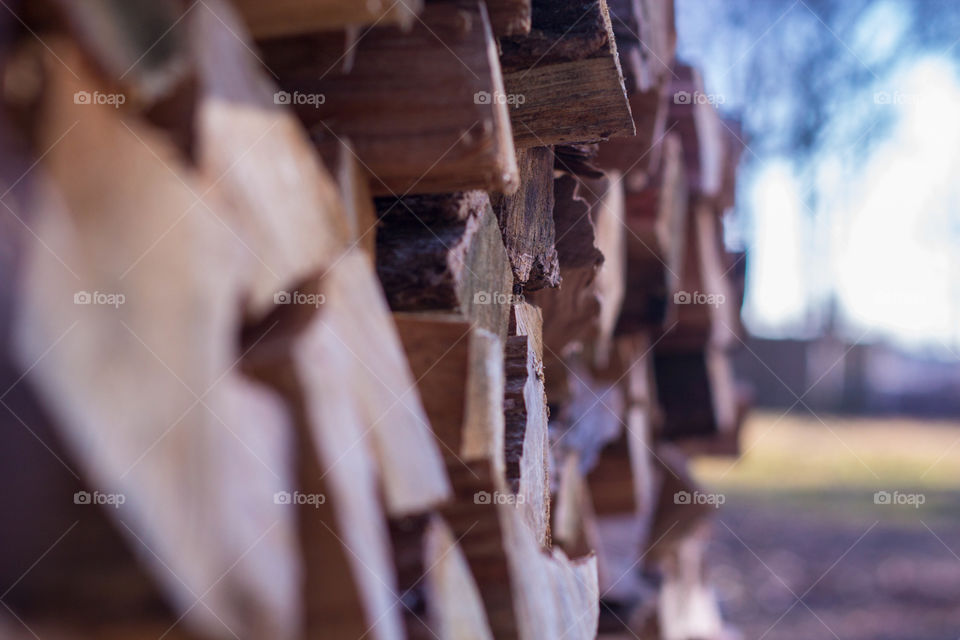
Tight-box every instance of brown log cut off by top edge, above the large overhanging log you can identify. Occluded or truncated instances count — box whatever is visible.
[233,0,423,38]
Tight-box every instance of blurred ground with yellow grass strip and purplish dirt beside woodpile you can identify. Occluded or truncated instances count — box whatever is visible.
[696,414,960,640]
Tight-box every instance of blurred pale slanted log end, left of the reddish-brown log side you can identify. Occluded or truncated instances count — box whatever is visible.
[245,249,449,516]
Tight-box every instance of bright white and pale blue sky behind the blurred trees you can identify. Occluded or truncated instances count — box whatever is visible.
[677,0,960,359]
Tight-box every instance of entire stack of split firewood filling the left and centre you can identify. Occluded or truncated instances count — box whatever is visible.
[0,0,743,640]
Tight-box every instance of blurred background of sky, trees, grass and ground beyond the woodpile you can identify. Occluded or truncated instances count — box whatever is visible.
[677,0,960,640]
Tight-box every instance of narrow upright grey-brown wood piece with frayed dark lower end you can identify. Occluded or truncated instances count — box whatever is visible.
[492,147,560,291]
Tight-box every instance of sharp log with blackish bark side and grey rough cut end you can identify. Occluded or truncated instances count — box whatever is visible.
[377,192,514,341]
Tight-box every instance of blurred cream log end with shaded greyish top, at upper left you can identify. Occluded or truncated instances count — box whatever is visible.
[188,0,350,319]
